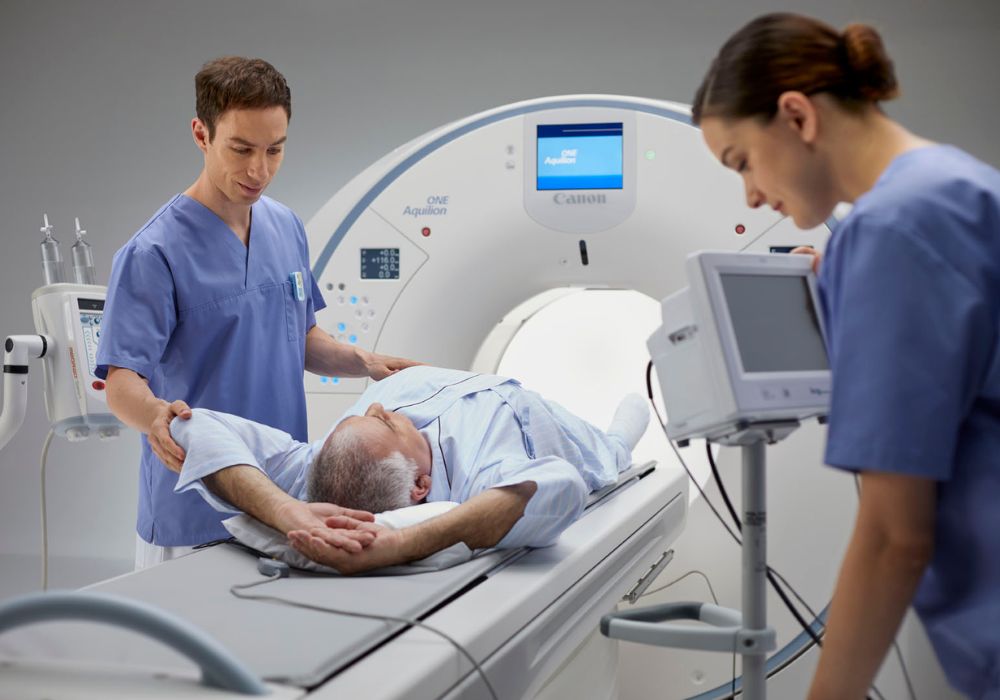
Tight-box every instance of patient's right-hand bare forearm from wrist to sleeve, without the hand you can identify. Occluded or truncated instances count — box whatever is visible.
[400,481,538,561]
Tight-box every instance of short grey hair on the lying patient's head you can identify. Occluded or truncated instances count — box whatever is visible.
[307,426,417,513]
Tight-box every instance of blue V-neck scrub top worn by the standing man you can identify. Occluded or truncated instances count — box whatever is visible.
[97,195,325,546]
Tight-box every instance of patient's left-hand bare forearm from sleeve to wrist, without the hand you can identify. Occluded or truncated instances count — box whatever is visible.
[202,464,301,533]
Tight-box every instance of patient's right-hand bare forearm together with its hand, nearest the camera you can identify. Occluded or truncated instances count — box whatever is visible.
[288,481,537,574]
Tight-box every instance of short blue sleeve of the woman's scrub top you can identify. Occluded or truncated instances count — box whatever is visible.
[824,218,994,480]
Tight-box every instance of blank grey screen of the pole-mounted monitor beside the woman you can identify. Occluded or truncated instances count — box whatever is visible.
[720,273,830,372]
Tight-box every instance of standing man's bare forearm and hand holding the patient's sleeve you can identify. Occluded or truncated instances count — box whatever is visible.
[107,367,191,472]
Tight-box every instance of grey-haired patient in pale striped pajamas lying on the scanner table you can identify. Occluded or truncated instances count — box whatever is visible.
[171,366,649,573]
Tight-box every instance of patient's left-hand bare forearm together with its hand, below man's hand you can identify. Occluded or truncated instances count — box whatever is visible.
[202,465,375,552]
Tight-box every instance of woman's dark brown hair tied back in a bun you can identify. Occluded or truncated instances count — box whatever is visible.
[692,13,899,124]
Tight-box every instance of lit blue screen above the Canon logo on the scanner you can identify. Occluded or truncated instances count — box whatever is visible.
[537,122,622,190]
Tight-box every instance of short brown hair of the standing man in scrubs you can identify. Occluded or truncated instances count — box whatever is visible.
[194,56,292,140]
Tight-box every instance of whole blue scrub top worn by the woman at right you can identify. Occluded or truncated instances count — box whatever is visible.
[819,146,1000,697]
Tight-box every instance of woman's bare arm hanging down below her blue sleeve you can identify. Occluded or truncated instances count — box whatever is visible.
[809,472,937,700]
